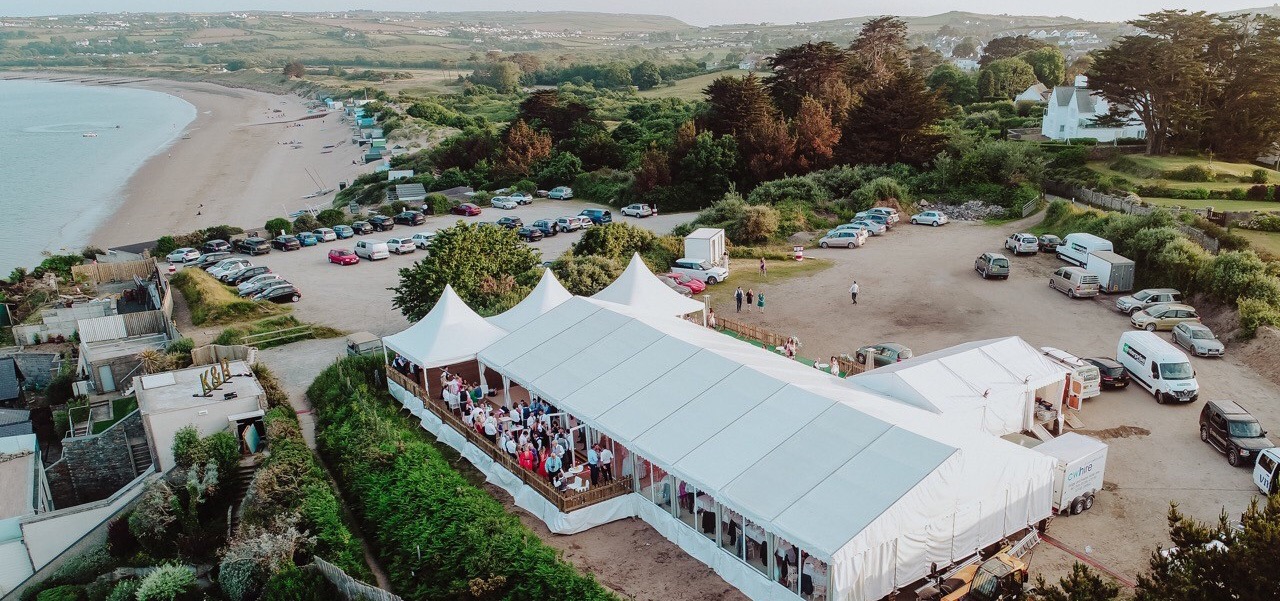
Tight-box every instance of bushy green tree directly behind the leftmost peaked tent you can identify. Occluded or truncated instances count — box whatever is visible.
[392,221,539,321]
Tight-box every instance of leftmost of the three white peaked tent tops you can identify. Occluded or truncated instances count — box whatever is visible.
[383,285,507,367]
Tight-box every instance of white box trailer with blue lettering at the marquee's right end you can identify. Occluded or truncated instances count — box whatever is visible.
[1034,432,1107,515]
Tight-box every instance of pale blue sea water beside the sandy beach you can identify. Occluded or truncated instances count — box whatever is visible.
[0,79,196,277]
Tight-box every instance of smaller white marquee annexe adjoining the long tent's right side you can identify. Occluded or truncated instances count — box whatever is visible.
[849,336,1068,436]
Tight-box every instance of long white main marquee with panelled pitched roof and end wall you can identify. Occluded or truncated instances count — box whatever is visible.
[465,298,1053,600]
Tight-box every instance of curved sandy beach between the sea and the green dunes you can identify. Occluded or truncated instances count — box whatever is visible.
[37,79,371,247]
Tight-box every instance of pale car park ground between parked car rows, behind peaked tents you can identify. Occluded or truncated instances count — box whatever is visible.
[184,198,691,335]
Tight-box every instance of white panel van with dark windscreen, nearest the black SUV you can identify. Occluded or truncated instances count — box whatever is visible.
[1116,331,1199,404]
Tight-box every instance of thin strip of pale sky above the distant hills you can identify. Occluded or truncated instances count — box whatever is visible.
[0,0,1275,26]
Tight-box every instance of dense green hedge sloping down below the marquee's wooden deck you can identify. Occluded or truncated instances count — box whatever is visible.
[307,357,617,601]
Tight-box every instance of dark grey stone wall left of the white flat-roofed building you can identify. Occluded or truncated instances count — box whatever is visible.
[63,410,146,503]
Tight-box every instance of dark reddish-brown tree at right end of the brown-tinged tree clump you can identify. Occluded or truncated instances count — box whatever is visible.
[838,72,948,165]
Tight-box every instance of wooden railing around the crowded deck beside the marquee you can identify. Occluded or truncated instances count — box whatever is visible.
[387,370,632,513]
